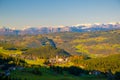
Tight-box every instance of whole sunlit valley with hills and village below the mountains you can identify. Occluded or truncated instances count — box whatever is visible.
[0,30,120,80]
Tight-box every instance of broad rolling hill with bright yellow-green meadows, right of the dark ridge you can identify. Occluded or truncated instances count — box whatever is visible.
[45,30,120,57]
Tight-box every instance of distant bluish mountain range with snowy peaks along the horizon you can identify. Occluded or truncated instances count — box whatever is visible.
[0,22,120,35]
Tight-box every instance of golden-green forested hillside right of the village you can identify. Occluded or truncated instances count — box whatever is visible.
[71,54,120,74]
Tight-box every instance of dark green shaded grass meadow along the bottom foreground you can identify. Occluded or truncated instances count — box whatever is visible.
[10,68,106,80]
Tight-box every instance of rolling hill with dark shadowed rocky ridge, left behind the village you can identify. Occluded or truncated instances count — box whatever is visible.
[0,35,70,60]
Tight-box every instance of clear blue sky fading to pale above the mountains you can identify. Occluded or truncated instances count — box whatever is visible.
[0,0,120,28]
